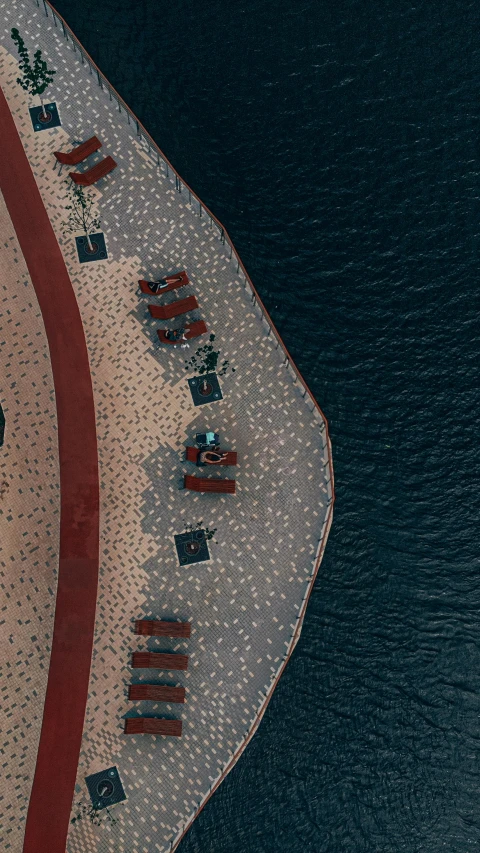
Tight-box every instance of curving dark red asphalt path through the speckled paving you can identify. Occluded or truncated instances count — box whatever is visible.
[0,89,99,853]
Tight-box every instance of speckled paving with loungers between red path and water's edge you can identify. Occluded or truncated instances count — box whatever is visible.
[0,0,331,853]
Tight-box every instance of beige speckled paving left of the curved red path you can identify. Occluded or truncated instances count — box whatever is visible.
[0,195,60,851]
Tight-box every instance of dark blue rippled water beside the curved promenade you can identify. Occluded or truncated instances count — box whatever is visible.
[52,0,480,853]
